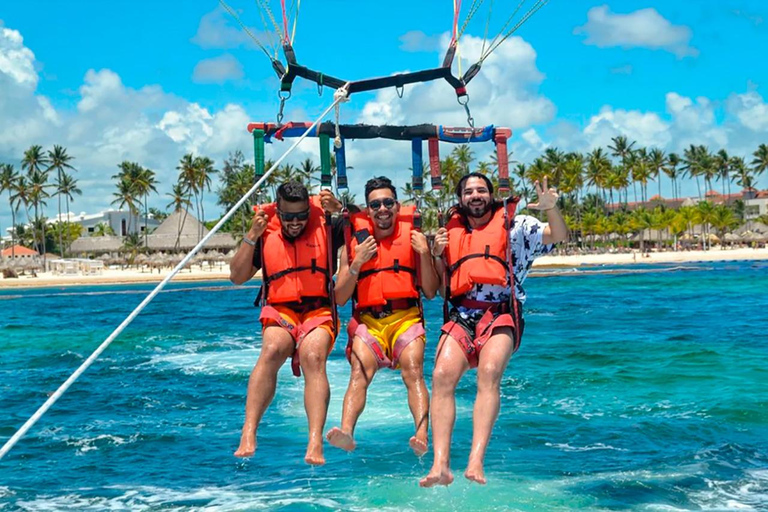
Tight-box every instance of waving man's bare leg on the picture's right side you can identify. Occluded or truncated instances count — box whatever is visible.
[464,327,514,484]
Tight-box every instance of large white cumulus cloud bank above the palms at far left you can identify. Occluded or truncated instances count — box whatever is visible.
[0,26,268,226]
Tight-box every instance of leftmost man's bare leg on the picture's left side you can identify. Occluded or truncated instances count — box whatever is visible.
[235,326,294,457]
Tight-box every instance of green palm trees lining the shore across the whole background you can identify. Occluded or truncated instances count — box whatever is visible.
[0,136,768,255]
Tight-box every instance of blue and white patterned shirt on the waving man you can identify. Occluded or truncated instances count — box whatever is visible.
[458,215,555,316]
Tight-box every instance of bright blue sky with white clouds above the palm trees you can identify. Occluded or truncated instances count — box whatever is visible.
[0,0,768,227]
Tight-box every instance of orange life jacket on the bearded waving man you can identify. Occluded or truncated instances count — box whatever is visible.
[445,200,517,298]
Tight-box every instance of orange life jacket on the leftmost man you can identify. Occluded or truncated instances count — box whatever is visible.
[261,196,331,304]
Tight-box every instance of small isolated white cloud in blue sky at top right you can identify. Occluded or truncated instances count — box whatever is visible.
[574,5,699,58]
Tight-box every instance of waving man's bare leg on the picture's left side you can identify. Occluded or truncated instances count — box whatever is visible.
[419,334,469,487]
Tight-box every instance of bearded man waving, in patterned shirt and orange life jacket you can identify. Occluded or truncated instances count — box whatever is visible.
[419,173,568,487]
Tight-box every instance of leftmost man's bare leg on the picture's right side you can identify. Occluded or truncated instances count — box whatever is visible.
[299,329,332,465]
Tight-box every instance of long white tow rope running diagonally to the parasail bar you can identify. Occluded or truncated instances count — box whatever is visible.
[0,84,349,459]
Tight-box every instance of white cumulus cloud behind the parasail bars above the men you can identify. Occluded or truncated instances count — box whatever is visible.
[348,34,556,186]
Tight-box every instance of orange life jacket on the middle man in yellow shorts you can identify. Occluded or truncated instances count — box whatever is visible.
[347,206,419,308]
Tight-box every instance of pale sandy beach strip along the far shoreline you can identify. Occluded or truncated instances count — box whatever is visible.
[0,247,768,289]
